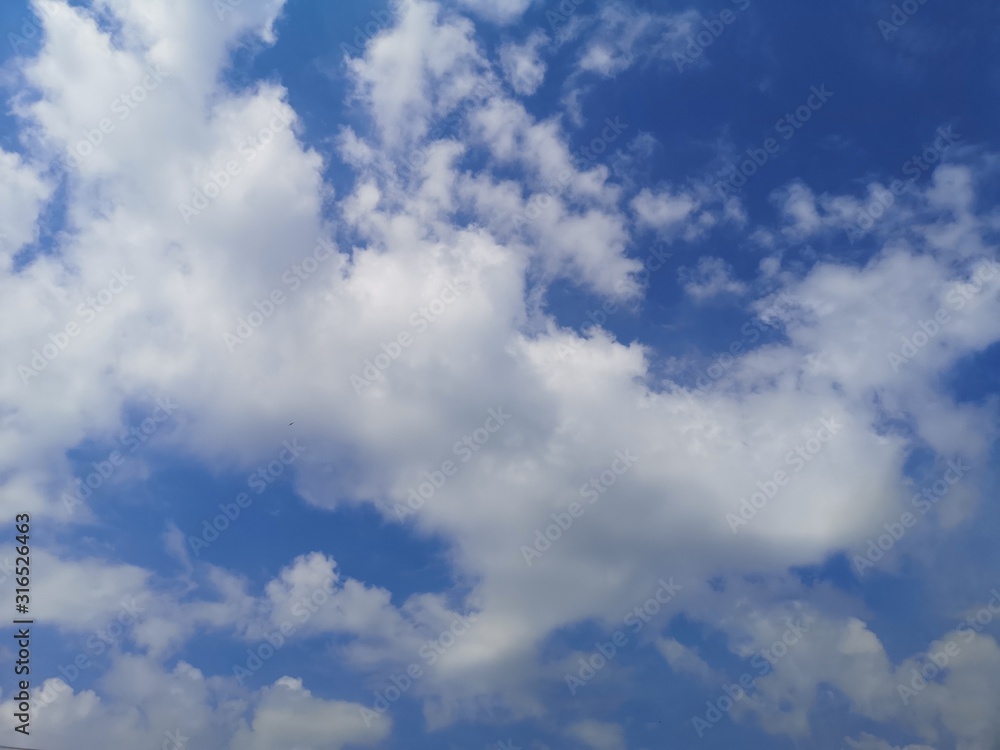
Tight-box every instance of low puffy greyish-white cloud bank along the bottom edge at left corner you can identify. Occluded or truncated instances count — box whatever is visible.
[0,655,392,750]
